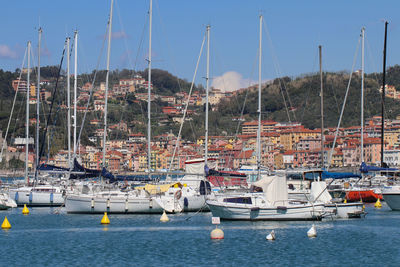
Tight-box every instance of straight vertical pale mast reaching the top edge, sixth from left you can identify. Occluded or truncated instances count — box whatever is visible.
[147,0,153,178]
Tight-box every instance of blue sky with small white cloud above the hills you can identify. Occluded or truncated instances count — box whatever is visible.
[0,0,400,91]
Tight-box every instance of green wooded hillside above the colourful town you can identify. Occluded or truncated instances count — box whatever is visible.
[0,65,400,157]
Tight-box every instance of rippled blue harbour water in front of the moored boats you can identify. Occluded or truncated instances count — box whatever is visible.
[0,204,400,267]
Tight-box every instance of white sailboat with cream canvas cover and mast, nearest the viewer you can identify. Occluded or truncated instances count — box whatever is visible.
[207,15,325,221]
